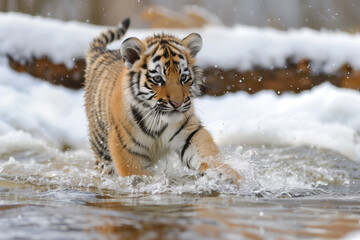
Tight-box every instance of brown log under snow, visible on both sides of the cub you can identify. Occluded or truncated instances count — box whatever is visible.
[9,56,360,96]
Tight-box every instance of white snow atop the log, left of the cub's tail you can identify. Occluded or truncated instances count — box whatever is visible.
[0,13,102,68]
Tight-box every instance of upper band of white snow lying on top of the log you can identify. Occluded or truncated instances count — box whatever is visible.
[0,13,360,73]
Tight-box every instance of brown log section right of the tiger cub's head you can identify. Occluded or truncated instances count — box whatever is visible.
[204,59,360,96]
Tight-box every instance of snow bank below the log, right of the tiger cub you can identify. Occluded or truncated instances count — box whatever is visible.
[196,83,360,161]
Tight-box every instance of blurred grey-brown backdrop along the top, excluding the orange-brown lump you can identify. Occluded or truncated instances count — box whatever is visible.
[0,0,360,32]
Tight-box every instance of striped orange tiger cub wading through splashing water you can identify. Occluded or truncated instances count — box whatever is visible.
[85,19,241,181]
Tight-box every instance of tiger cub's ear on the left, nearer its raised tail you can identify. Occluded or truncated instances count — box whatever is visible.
[120,38,145,69]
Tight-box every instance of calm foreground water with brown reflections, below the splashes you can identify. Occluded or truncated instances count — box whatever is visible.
[0,187,360,239]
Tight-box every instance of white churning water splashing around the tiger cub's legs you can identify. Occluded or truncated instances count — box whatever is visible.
[0,132,359,197]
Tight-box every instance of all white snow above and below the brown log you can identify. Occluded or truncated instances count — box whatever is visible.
[0,13,360,161]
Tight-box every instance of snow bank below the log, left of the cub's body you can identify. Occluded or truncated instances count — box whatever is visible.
[0,63,87,148]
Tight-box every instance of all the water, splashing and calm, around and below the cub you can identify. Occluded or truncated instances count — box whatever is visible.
[0,143,360,239]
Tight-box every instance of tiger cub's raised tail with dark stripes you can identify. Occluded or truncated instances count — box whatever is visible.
[87,18,130,59]
